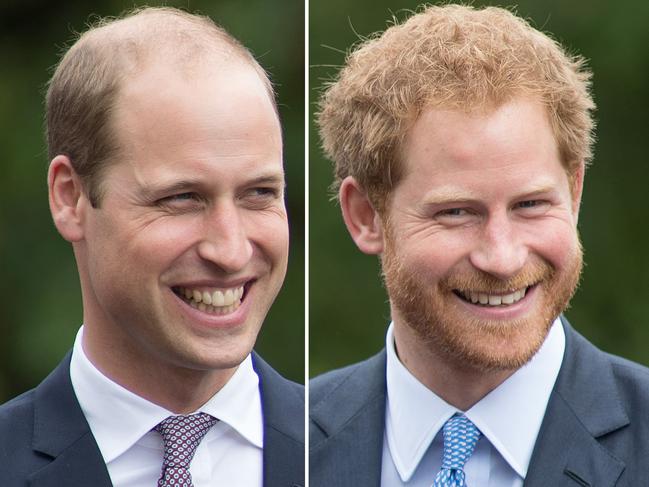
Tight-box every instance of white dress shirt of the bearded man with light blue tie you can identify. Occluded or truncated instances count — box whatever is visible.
[381,319,565,487]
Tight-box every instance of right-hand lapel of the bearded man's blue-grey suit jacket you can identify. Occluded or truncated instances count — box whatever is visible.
[524,319,629,487]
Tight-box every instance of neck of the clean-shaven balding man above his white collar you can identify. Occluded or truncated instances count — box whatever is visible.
[82,325,237,414]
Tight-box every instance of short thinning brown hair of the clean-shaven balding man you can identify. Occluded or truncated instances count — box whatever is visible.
[45,7,277,206]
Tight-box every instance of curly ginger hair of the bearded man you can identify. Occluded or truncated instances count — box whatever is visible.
[317,5,595,211]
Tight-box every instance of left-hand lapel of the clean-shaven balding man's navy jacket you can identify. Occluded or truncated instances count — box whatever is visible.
[29,354,112,487]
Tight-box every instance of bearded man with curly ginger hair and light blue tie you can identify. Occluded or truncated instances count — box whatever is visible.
[309,5,649,487]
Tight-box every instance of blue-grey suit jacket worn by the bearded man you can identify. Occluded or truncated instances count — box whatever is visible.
[309,318,649,487]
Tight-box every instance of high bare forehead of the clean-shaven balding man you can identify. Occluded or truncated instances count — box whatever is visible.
[107,60,282,180]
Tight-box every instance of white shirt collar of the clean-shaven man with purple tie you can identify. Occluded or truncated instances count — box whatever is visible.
[70,326,263,463]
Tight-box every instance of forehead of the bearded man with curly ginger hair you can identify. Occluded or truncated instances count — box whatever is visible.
[397,99,565,197]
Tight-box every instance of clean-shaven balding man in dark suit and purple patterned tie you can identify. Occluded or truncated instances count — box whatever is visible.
[0,8,304,487]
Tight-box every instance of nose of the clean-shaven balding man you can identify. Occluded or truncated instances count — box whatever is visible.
[198,204,253,274]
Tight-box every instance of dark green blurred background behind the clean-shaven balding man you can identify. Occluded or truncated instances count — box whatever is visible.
[0,0,305,403]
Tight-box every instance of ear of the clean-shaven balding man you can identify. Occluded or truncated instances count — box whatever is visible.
[47,155,88,242]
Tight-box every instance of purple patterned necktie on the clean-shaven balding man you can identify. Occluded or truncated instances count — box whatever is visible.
[153,413,218,487]
